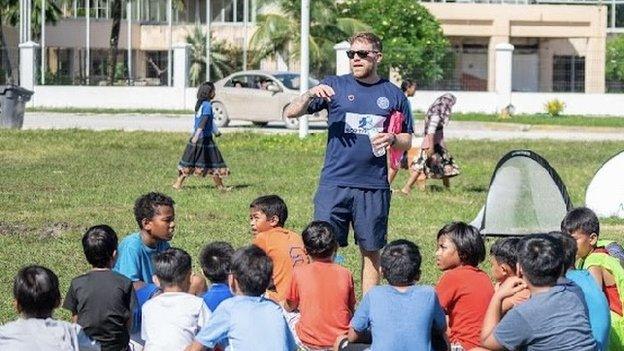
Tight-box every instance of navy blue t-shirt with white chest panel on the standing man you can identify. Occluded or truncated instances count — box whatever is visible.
[308,74,413,189]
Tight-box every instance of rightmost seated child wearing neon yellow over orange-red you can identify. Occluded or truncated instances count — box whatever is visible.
[561,207,624,351]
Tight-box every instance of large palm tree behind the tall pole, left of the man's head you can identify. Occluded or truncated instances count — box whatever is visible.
[250,0,370,74]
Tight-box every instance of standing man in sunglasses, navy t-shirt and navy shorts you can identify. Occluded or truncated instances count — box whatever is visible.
[284,33,413,293]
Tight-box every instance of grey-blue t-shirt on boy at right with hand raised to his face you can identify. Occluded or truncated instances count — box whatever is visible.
[494,278,598,351]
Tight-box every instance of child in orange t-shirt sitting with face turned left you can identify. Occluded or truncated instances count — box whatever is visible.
[249,195,309,302]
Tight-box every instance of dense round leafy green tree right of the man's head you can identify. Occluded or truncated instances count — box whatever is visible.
[341,0,453,83]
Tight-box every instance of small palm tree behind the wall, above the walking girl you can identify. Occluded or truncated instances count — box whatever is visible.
[186,26,243,86]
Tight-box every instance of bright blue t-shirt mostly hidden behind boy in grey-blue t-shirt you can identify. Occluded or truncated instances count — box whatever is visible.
[566,269,611,351]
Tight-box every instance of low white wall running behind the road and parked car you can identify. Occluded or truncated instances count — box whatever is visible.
[28,85,624,116]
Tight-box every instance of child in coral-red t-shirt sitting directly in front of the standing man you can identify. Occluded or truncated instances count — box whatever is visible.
[284,221,355,350]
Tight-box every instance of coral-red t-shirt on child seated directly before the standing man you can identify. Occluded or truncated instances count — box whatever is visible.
[286,261,355,348]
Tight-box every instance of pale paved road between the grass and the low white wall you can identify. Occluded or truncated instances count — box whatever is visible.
[24,112,624,141]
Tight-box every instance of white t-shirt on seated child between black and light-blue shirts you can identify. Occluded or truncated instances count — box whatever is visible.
[141,292,210,351]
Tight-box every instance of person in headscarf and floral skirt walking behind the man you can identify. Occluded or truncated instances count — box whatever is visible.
[401,93,459,194]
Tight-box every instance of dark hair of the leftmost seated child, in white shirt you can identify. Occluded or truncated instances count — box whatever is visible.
[13,266,61,318]
